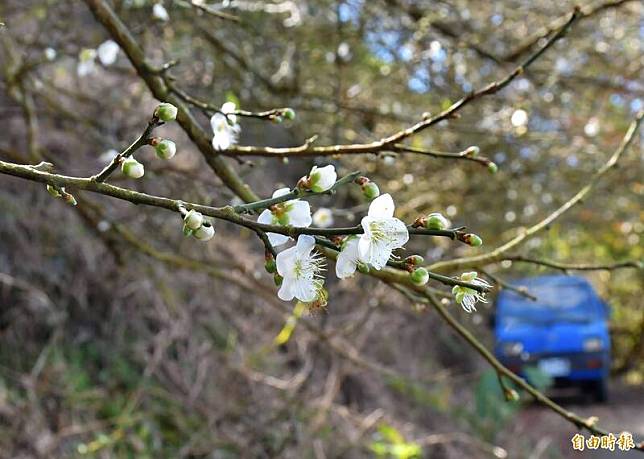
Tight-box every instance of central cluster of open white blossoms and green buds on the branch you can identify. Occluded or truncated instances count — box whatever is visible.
[252,165,490,312]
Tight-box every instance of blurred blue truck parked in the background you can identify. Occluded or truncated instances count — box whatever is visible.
[494,275,610,402]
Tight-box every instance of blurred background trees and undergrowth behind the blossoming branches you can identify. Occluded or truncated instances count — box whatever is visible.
[0,0,644,458]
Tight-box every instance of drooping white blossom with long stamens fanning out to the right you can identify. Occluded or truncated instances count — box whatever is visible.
[275,234,324,303]
